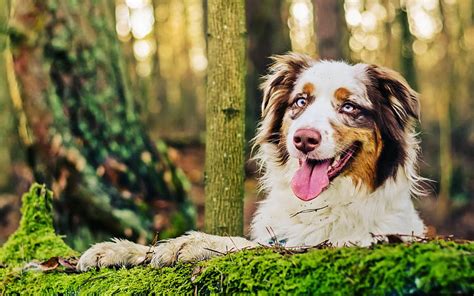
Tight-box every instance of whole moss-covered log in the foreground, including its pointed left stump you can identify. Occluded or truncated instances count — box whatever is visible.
[0,185,474,295]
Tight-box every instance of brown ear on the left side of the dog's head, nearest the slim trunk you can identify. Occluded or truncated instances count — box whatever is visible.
[260,53,311,117]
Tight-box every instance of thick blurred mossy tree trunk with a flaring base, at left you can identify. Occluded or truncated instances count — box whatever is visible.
[10,0,191,249]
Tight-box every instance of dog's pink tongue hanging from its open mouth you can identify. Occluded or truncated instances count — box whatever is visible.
[291,160,330,201]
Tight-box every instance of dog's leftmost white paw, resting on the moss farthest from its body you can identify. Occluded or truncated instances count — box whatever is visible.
[76,239,150,271]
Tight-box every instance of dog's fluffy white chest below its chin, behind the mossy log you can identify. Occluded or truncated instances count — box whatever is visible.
[252,184,400,247]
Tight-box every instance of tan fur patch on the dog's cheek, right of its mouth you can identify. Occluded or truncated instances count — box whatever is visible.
[333,125,383,191]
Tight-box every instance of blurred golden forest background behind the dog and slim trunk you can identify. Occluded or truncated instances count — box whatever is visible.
[0,0,474,250]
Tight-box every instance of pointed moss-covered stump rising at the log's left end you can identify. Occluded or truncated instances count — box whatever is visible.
[0,184,77,265]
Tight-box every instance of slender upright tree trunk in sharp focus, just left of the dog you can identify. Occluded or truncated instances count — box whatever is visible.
[205,0,246,235]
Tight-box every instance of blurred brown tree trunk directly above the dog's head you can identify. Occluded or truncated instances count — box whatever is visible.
[313,0,348,60]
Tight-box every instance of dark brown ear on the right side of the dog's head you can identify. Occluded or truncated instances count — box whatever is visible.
[366,65,420,140]
